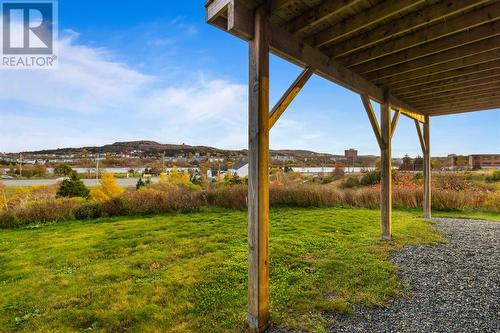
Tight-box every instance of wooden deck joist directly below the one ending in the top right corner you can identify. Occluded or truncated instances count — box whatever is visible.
[354,17,500,73]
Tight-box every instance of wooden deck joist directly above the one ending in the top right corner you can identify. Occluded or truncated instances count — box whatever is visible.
[326,0,491,58]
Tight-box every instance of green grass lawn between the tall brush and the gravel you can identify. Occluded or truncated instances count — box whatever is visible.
[0,208,454,332]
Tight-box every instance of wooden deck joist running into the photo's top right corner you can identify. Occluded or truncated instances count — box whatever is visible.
[345,2,500,67]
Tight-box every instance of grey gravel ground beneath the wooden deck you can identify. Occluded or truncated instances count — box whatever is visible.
[329,218,500,333]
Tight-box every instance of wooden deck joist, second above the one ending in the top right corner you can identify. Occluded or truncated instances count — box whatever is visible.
[306,0,424,47]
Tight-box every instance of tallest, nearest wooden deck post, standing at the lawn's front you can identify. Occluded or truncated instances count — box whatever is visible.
[248,6,269,333]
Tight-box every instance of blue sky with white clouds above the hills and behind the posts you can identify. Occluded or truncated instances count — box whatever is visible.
[0,0,500,156]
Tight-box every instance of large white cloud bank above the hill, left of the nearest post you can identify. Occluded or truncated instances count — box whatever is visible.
[0,29,247,151]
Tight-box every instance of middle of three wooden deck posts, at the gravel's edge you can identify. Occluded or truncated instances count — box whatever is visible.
[380,102,392,240]
